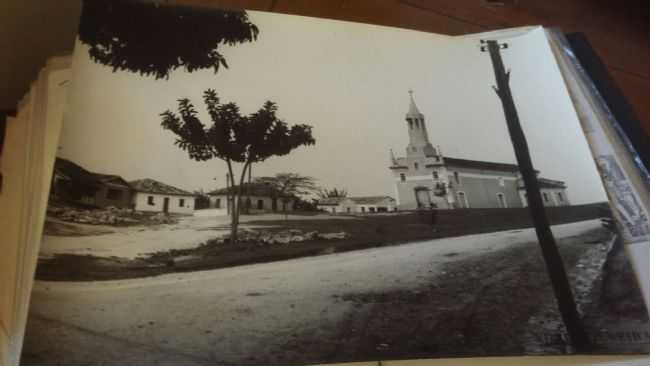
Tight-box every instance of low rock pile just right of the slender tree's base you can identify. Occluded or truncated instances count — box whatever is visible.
[220,229,349,244]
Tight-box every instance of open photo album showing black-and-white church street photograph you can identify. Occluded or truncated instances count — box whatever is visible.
[0,0,650,366]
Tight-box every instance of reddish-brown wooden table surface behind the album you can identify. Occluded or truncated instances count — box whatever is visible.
[0,0,650,136]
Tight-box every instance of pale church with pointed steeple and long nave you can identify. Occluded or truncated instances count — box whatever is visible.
[389,91,570,210]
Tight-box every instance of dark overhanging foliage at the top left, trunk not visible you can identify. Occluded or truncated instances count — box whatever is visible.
[79,0,259,79]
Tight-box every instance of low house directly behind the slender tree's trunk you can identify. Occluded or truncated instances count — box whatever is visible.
[208,183,297,214]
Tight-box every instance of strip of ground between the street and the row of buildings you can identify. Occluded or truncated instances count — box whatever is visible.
[36,210,597,281]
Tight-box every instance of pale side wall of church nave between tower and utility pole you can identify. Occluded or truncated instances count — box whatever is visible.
[447,166,522,208]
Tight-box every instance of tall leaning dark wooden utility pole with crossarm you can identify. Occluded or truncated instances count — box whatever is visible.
[481,40,589,350]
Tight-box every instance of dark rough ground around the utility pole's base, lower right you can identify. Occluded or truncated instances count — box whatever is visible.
[310,229,650,361]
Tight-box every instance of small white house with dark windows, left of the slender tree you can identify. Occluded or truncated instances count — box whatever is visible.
[129,178,195,215]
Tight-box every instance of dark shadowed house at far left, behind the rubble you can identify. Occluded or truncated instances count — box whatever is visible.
[50,158,132,208]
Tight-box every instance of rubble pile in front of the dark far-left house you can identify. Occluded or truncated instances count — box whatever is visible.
[47,207,176,225]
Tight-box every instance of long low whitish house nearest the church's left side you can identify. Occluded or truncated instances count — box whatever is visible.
[316,196,397,214]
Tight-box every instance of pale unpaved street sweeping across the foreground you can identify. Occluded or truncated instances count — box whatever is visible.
[23,220,600,366]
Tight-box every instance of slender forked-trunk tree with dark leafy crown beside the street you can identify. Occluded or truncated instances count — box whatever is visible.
[160,89,316,243]
